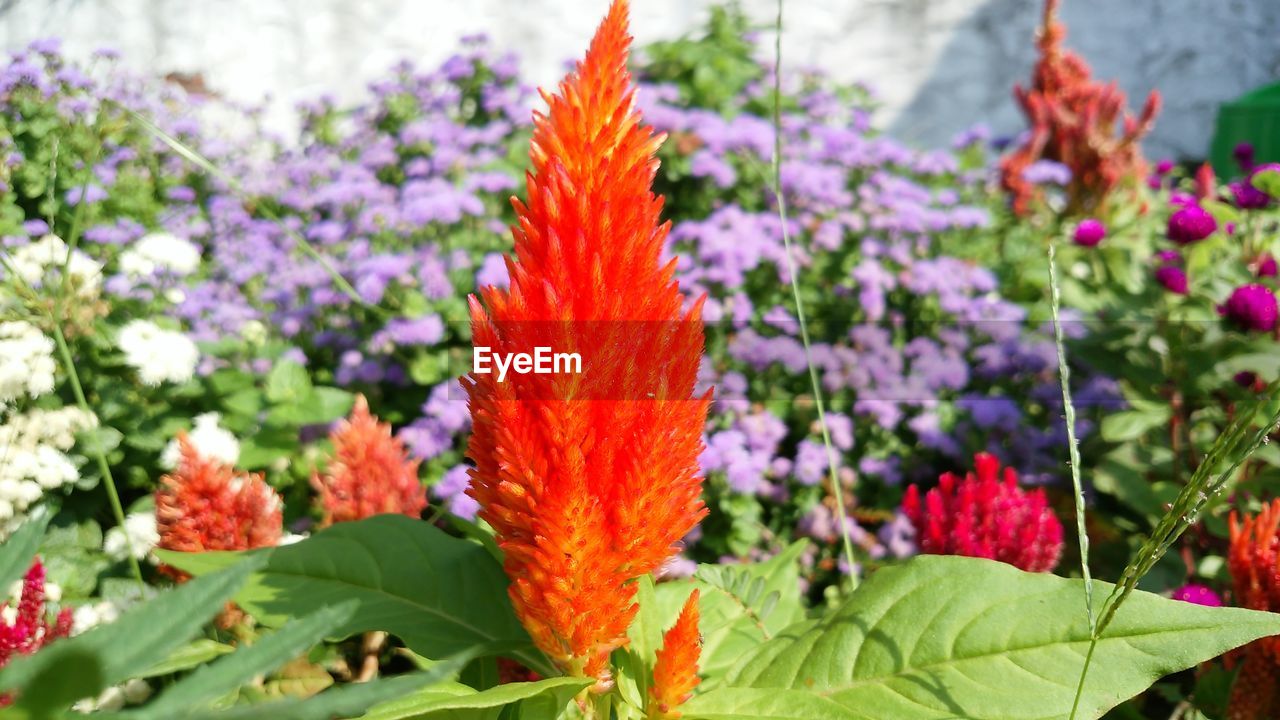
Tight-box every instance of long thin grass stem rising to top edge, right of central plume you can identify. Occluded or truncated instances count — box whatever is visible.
[773,0,858,587]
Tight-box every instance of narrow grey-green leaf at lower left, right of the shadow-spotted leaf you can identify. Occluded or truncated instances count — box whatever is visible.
[147,602,356,714]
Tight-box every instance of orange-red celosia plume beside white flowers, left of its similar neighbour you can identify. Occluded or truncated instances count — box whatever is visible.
[156,434,283,580]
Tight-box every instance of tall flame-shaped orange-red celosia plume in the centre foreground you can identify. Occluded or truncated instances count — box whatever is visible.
[463,0,710,689]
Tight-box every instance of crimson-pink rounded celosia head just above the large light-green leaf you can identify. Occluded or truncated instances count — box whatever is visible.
[902,452,1062,573]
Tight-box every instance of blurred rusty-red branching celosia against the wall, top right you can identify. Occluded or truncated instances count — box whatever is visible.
[1000,0,1160,217]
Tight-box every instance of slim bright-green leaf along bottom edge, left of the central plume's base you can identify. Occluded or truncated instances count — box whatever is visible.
[361,678,591,720]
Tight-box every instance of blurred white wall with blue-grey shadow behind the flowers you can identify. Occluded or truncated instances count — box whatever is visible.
[0,0,1280,158]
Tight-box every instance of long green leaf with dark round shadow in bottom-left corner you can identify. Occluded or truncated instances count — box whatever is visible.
[0,560,257,716]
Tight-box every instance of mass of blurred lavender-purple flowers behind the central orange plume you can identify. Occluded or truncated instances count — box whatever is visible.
[0,32,1114,570]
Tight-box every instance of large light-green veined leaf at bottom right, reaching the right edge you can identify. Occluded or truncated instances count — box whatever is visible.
[682,556,1280,720]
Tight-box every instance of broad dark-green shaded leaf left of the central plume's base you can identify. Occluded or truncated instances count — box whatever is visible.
[160,515,552,674]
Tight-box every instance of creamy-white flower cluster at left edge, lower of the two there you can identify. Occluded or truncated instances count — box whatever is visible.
[0,407,97,538]
